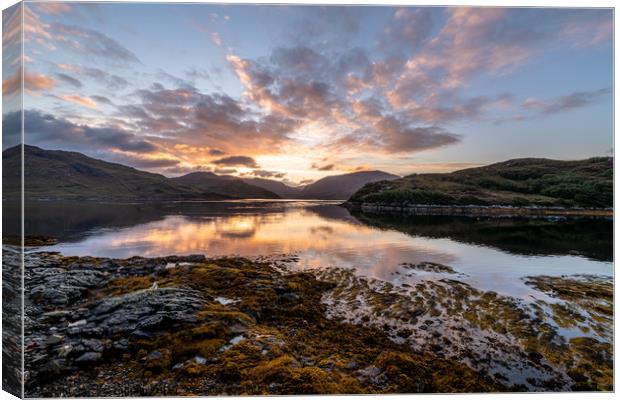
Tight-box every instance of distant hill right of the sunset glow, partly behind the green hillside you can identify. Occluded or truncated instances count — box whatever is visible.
[299,171,399,200]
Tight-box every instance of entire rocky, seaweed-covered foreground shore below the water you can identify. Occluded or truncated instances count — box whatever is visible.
[3,246,613,397]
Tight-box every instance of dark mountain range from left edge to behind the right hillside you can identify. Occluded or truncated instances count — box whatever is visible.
[2,145,399,201]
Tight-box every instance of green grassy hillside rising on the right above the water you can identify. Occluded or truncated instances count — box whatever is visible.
[349,157,613,207]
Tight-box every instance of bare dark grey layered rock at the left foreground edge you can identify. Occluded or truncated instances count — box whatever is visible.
[24,253,204,390]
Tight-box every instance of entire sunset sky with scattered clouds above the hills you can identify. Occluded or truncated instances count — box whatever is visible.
[2,3,613,185]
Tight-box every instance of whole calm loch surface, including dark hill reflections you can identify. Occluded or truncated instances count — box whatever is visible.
[17,200,613,298]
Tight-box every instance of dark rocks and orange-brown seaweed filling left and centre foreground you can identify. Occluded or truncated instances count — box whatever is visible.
[19,248,505,397]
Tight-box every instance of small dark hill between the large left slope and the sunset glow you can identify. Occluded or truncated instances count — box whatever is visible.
[170,172,280,199]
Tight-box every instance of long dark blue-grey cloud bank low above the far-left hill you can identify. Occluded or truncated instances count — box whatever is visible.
[2,110,157,154]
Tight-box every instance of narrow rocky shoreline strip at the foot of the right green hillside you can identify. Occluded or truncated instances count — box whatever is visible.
[342,201,614,218]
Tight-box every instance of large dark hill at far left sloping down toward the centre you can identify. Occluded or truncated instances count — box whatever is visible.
[2,145,276,201]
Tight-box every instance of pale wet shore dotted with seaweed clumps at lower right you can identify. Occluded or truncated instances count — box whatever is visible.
[317,263,613,391]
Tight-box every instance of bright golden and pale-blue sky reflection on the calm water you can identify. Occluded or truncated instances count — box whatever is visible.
[35,202,613,298]
